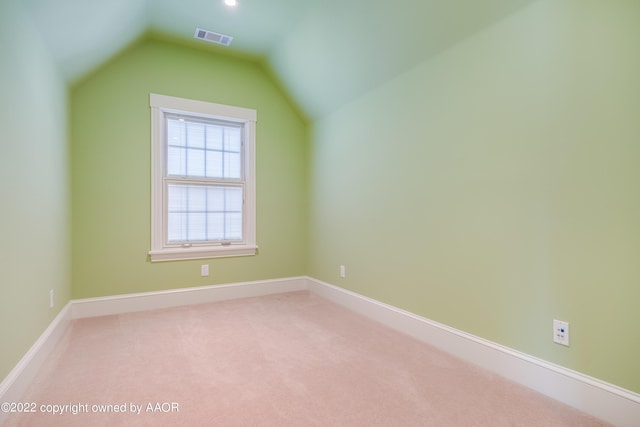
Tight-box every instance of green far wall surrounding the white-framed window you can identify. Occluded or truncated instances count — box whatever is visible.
[70,38,308,298]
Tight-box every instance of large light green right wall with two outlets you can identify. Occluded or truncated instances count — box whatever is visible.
[309,0,640,392]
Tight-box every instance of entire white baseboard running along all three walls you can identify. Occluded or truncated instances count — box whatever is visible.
[0,277,640,427]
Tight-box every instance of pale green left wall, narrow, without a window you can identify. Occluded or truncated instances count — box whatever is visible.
[0,0,71,381]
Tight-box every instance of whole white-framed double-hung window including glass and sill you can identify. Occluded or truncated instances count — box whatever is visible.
[149,94,257,261]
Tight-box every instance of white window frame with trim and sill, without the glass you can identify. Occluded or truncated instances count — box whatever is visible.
[149,93,258,262]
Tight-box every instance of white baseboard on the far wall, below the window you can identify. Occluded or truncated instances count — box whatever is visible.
[72,277,307,319]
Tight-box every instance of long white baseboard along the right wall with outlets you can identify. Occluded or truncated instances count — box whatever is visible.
[307,278,640,427]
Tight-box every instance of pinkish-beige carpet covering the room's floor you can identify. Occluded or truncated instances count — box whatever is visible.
[6,292,605,427]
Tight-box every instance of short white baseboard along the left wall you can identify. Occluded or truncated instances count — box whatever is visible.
[0,303,71,425]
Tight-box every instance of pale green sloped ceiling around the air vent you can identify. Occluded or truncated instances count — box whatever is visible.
[21,0,535,118]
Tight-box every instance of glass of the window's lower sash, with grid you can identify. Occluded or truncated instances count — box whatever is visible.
[167,184,243,243]
